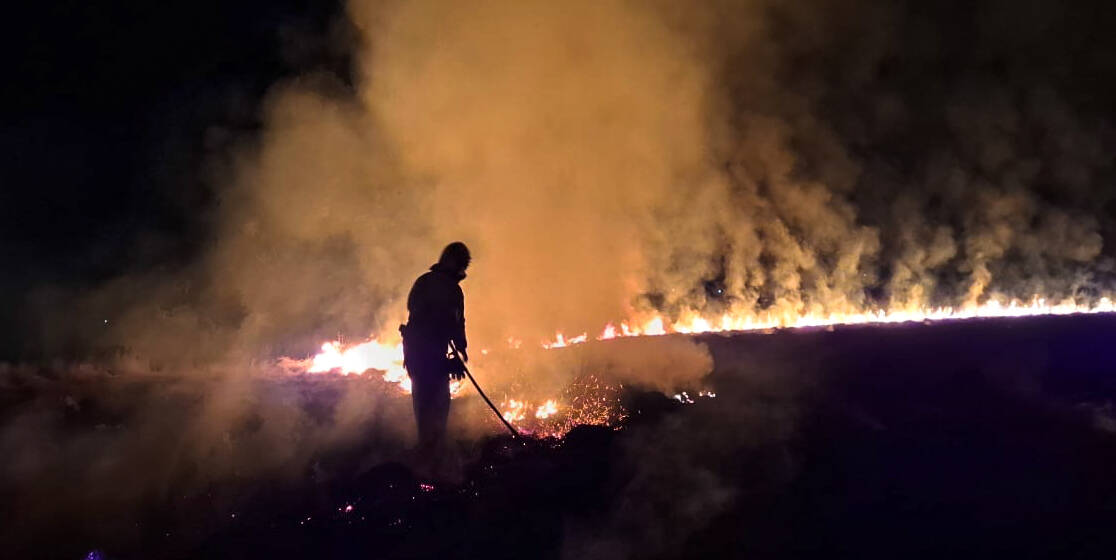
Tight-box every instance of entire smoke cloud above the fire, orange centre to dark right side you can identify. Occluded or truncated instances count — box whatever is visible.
[48,0,1113,359]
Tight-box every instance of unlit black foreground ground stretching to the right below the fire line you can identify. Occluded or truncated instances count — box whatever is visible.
[3,316,1116,559]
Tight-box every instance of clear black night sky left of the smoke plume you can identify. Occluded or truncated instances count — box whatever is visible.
[0,0,346,354]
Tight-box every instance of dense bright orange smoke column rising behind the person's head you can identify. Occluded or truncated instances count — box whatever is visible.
[208,2,710,346]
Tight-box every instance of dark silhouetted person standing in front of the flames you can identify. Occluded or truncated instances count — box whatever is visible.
[400,241,471,463]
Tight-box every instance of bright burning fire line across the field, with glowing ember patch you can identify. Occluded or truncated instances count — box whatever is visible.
[279,297,1116,437]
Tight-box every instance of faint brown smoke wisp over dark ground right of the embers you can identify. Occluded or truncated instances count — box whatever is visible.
[562,342,803,558]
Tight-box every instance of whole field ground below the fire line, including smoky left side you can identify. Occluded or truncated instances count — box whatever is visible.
[3,313,1116,558]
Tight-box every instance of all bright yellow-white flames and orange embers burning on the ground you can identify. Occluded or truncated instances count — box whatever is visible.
[280,297,1116,437]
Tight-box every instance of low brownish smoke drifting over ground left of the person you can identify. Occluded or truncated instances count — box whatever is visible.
[0,364,410,550]
